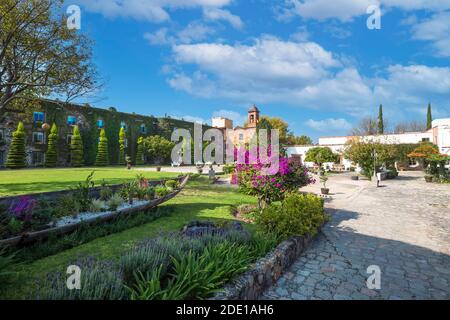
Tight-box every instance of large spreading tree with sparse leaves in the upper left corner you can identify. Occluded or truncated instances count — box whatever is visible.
[0,0,98,110]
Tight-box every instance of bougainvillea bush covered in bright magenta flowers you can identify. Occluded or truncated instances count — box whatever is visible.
[232,148,315,210]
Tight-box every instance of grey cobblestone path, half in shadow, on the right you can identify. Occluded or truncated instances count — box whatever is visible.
[261,173,450,300]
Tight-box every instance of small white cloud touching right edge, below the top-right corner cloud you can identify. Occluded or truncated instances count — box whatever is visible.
[412,12,450,57]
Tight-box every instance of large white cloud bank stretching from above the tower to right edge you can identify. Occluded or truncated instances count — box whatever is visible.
[163,36,450,117]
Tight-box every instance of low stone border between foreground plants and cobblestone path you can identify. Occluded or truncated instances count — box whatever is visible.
[210,222,322,300]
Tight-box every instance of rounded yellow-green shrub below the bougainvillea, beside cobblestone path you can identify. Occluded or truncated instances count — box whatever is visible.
[257,194,327,238]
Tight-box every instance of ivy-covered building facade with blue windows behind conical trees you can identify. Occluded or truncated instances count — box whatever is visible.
[0,100,202,167]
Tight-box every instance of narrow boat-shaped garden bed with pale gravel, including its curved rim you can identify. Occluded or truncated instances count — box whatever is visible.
[0,176,189,247]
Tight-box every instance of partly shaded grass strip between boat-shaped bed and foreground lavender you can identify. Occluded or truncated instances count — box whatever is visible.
[0,178,255,299]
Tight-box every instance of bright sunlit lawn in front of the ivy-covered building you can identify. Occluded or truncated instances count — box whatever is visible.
[0,167,179,197]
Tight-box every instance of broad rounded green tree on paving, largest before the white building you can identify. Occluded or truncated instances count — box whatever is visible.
[344,140,395,179]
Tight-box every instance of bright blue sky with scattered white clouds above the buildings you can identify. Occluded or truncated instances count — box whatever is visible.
[66,0,450,139]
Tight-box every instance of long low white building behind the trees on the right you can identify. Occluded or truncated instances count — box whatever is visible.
[286,118,450,170]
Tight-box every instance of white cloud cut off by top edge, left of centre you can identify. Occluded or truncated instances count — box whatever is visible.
[78,0,232,23]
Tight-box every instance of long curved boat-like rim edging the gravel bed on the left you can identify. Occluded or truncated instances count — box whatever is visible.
[0,175,189,247]
